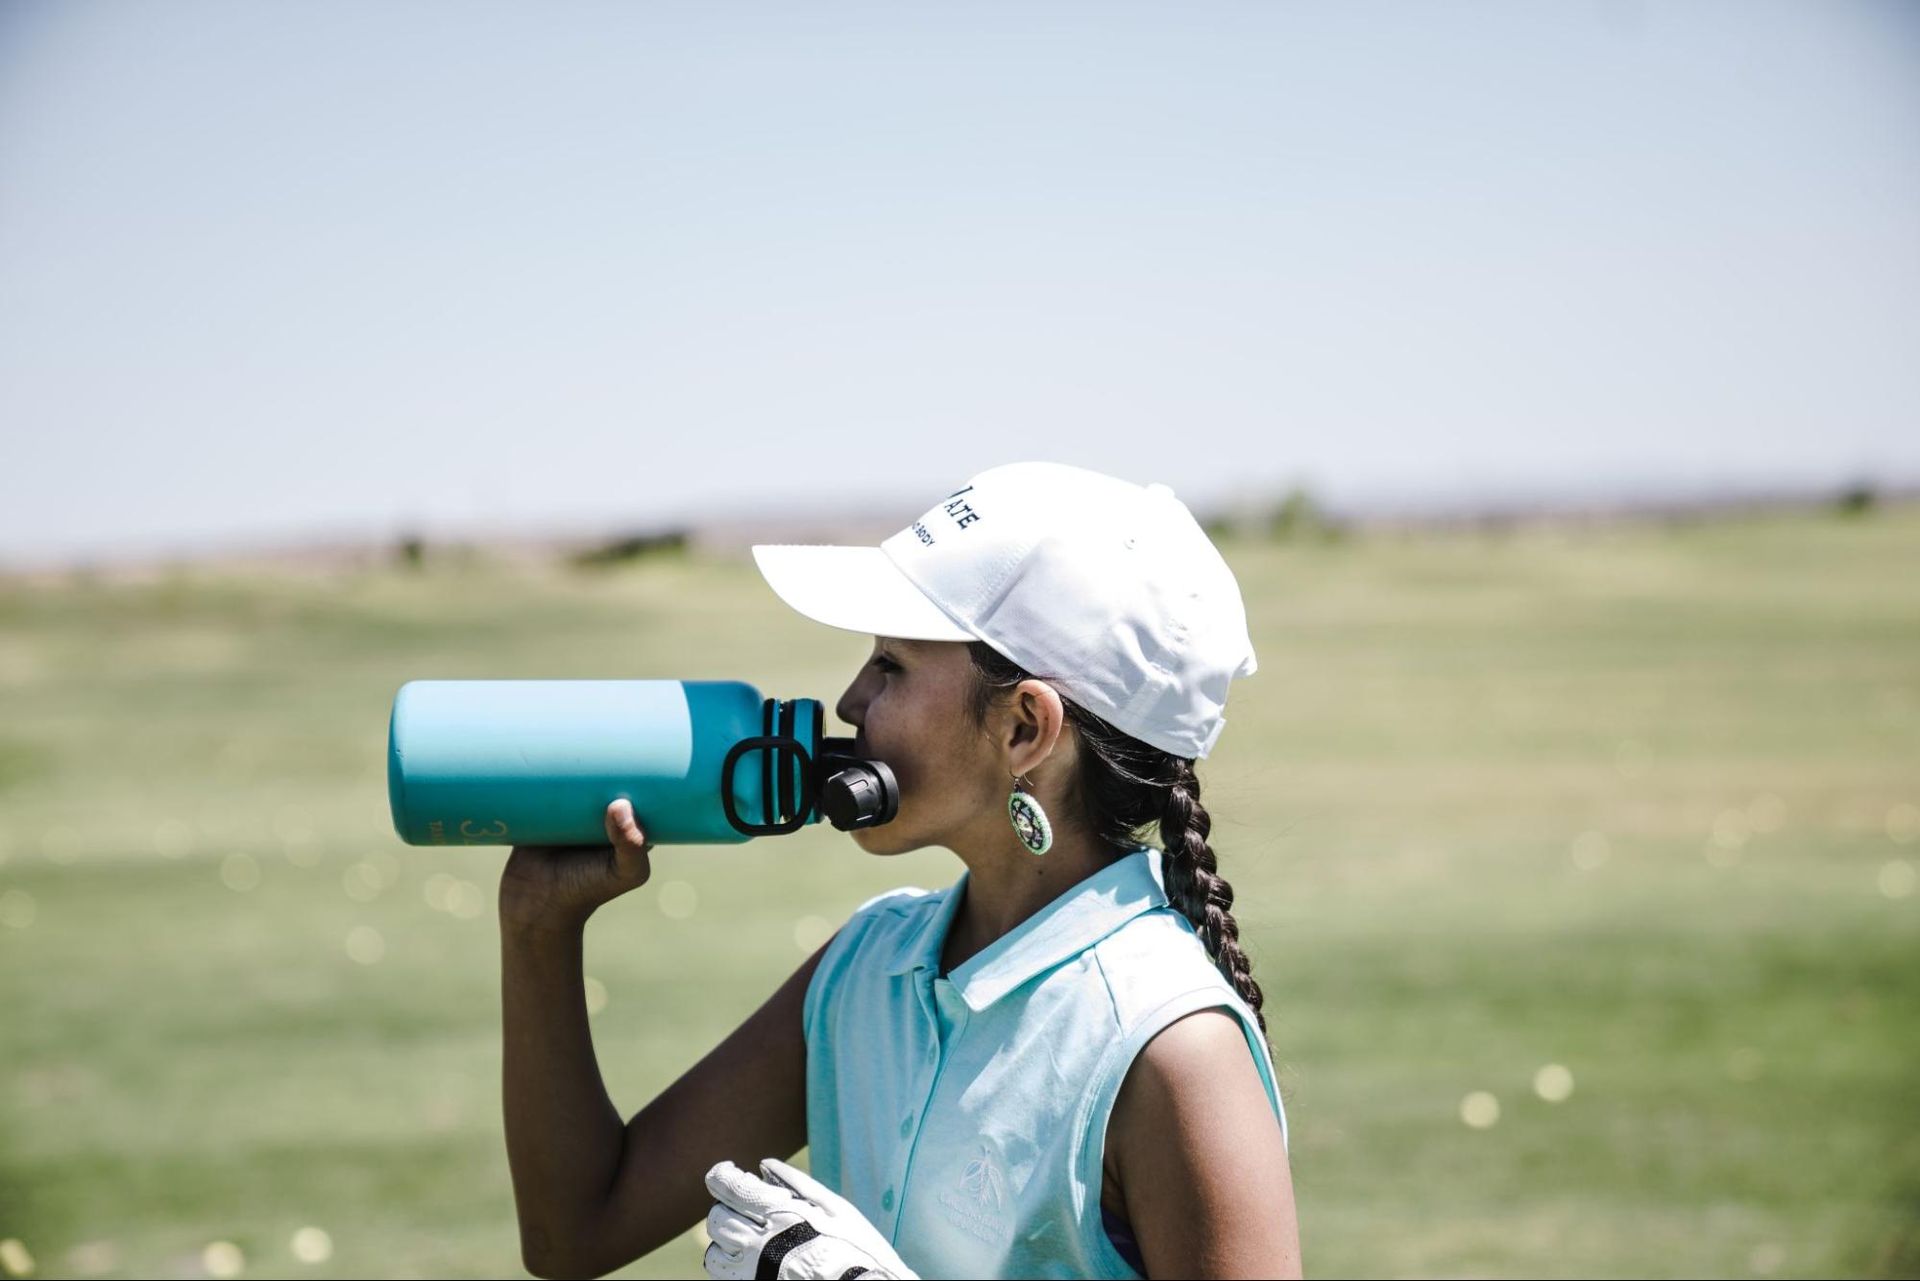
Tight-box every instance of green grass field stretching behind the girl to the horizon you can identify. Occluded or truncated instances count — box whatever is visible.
[0,507,1920,1277]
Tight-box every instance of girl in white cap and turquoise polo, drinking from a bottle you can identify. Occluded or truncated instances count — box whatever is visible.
[501,463,1300,1277]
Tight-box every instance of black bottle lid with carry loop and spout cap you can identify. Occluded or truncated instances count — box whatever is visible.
[720,699,900,837]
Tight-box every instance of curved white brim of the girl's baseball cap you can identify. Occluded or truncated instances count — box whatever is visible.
[753,544,975,641]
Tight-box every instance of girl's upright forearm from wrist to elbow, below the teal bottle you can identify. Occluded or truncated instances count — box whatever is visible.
[501,926,624,1273]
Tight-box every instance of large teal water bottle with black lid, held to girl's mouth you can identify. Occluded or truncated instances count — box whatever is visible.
[386,680,900,845]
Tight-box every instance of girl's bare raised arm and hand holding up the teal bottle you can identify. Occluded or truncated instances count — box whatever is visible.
[501,801,826,1277]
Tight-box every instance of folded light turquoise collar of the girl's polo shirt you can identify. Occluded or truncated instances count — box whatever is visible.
[887,845,1167,1014]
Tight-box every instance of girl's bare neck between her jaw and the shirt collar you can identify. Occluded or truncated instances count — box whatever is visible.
[941,816,1127,972]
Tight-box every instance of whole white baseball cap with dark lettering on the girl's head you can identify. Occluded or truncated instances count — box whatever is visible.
[753,463,1260,759]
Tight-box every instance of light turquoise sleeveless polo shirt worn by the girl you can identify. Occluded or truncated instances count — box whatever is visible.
[803,845,1286,1279]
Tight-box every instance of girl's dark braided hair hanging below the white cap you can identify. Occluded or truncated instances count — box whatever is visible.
[968,641,1267,1033]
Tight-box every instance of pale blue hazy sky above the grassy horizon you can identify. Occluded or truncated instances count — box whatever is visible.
[0,0,1920,563]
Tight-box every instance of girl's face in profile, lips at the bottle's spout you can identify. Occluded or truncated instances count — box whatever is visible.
[833,636,1012,855]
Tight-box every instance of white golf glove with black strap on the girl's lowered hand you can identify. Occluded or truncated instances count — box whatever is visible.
[701,1156,920,1281]
